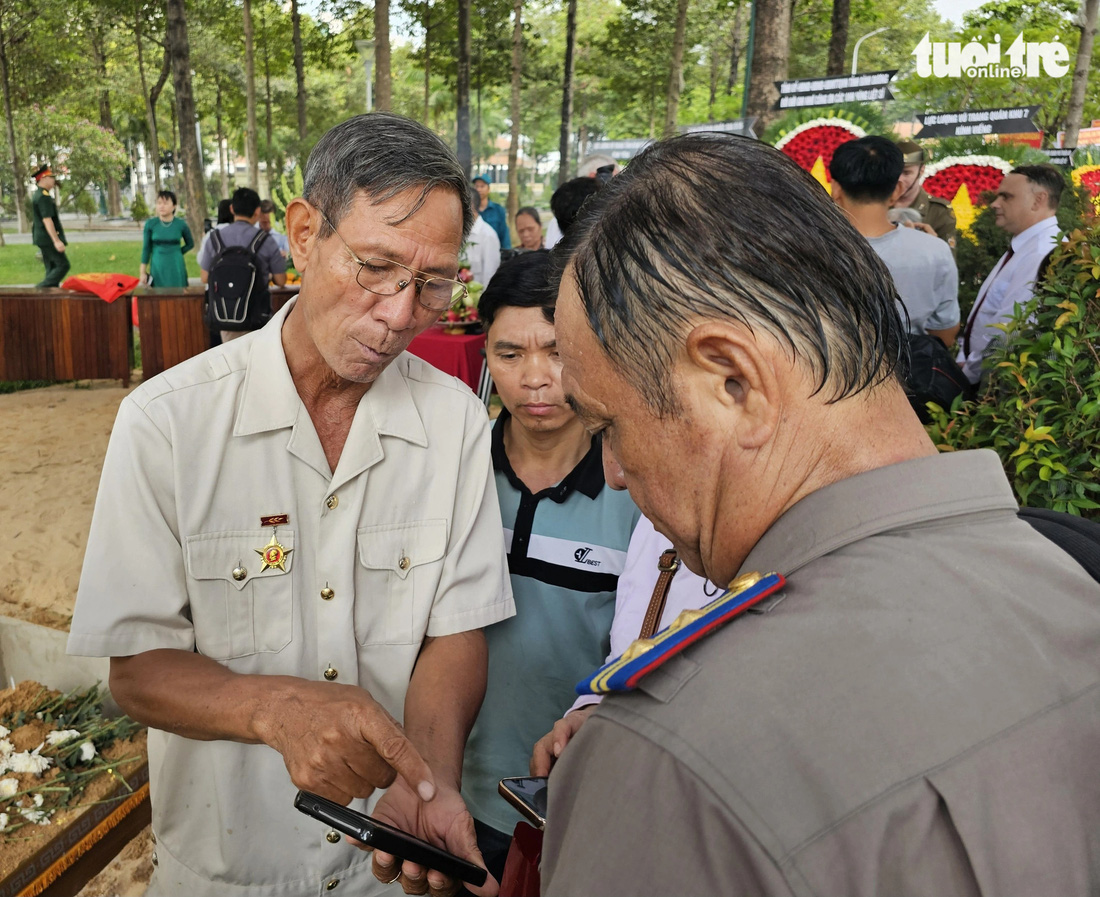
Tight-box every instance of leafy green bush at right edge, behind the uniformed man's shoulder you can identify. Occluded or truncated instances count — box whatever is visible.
[928,228,1100,518]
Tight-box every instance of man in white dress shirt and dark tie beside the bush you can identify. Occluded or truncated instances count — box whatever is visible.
[958,165,1065,384]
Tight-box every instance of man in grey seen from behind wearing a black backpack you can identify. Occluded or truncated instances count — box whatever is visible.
[198,187,286,342]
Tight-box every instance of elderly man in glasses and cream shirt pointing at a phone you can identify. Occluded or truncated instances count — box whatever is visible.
[69,114,514,897]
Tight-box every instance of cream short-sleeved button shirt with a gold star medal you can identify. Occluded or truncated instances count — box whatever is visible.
[68,301,514,897]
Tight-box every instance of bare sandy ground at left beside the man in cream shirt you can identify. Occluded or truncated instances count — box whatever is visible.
[0,381,152,897]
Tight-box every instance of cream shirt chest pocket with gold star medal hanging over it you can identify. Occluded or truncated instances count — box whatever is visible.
[185,528,294,660]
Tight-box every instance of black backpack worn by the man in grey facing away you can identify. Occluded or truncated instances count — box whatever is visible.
[205,229,272,330]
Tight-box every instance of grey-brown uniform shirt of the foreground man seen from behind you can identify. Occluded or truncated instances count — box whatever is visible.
[542,451,1100,897]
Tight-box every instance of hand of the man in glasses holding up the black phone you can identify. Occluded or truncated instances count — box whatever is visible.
[361,778,499,897]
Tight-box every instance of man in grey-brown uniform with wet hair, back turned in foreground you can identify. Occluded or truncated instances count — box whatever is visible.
[541,134,1100,895]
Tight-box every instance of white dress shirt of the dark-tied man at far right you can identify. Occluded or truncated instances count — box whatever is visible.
[957,220,1059,383]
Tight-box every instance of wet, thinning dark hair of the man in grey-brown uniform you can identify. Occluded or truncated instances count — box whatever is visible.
[553,134,909,416]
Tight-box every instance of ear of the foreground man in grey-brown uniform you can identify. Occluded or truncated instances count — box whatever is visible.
[685,321,782,449]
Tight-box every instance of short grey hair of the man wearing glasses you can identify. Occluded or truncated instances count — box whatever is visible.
[301,112,474,240]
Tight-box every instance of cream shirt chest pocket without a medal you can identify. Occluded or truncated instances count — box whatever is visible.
[355,519,447,645]
